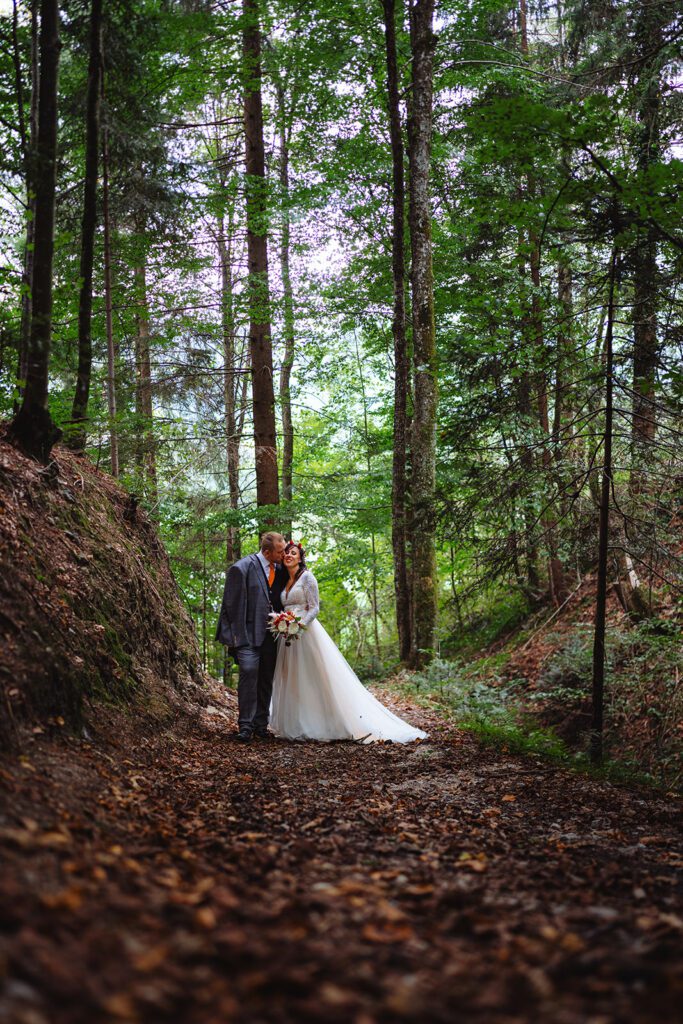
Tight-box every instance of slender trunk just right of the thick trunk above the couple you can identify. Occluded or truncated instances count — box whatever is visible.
[278,84,295,538]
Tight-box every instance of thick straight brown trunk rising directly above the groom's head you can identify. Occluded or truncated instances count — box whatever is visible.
[243,0,280,512]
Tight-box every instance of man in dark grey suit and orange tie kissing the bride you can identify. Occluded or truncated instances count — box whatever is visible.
[216,532,288,743]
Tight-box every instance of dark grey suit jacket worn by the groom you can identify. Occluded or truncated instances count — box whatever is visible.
[216,555,288,647]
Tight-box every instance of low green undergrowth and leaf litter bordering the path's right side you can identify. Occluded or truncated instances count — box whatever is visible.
[391,622,683,790]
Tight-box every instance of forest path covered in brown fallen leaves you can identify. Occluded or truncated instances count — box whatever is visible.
[0,688,683,1024]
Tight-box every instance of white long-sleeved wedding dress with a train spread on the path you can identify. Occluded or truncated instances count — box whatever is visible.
[270,569,427,743]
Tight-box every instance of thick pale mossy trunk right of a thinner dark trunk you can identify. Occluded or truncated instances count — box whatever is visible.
[408,0,438,664]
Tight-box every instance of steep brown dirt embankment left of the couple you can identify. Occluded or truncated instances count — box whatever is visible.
[0,438,206,743]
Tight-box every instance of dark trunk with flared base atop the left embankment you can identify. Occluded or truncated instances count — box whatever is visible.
[9,0,61,462]
